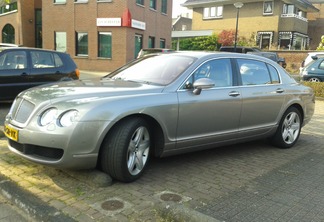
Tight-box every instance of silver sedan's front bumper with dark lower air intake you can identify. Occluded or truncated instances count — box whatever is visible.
[5,120,107,169]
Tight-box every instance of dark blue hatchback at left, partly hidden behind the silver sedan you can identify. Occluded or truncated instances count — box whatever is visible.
[0,47,80,101]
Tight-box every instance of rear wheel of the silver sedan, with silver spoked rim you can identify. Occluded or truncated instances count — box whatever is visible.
[271,107,302,149]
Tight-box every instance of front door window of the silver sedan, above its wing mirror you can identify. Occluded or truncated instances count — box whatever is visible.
[184,59,233,89]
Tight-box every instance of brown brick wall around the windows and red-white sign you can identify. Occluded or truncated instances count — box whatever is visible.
[43,0,172,71]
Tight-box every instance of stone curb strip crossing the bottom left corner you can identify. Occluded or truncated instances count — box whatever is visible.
[0,174,75,222]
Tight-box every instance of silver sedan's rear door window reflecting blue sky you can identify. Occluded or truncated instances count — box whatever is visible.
[237,59,272,86]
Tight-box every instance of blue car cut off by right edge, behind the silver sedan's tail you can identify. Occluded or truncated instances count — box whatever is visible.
[300,55,324,82]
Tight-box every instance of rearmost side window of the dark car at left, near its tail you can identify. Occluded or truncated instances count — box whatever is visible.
[30,51,63,69]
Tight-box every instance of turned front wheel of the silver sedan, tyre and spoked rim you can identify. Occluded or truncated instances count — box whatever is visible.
[99,118,151,182]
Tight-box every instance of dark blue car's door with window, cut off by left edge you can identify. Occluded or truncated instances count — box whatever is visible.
[0,50,30,100]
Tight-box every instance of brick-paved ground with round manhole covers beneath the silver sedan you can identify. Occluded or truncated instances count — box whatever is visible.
[0,100,324,222]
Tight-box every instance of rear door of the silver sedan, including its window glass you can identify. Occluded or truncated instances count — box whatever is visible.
[237,59,285,138]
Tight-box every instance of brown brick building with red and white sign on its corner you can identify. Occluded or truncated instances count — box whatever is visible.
[42,0,172,71]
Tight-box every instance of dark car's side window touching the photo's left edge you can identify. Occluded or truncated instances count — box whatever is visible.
[0,51,27,69]
